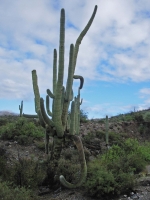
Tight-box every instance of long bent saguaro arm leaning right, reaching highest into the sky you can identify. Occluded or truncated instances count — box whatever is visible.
[74,5,97,74]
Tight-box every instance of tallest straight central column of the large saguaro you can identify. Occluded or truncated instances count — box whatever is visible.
[53,9,65,137]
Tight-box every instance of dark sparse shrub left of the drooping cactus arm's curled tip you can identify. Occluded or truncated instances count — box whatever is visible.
[1,158,46,189]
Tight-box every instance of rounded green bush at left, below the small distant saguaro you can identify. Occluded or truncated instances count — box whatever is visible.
[0,117,44,144]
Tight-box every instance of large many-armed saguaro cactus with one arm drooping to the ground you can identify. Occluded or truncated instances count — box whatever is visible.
[22,6,97,188]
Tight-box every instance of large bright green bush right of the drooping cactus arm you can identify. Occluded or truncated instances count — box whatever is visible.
[84,139,149,197]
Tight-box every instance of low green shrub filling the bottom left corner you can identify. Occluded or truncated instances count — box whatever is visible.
[0,182,39,200]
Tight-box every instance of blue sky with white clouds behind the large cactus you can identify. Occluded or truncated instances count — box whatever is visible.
[0,0,150,119]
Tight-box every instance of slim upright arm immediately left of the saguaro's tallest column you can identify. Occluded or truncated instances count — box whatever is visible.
[53,49,57,94]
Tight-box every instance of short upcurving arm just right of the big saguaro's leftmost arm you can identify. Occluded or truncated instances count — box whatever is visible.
[40,98,54,127]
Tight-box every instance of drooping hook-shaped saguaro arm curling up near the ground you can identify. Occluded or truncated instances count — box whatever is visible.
[59,135,87,188]
